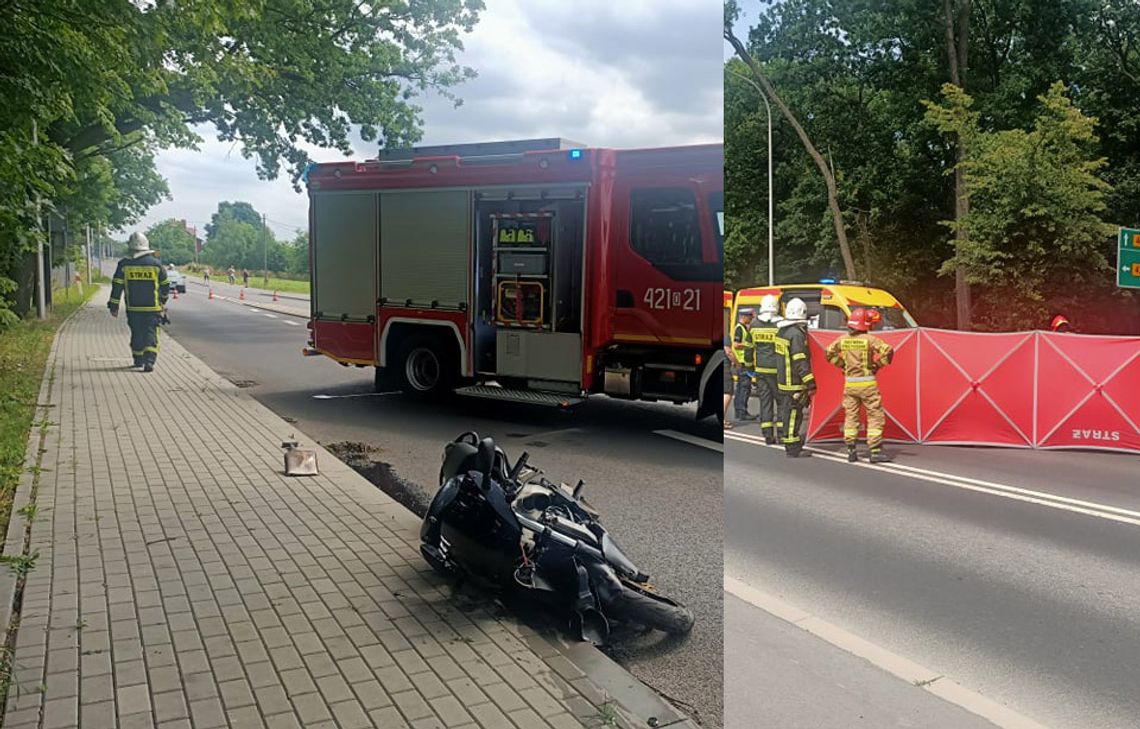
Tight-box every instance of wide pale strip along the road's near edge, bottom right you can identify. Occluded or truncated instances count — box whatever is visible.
[724,575,1045,729]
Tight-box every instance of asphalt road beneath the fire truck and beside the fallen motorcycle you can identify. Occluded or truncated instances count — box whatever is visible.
[158,283,724,727]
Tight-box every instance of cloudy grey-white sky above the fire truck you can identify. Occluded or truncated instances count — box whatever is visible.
[139,0,724,244]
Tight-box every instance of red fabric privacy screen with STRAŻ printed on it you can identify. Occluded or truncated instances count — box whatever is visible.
[807,329,1140,452]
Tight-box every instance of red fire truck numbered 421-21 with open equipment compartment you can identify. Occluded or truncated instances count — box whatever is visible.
[306,139,724,416]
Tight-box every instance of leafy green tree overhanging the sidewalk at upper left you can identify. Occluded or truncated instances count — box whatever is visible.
[0,0,483,321]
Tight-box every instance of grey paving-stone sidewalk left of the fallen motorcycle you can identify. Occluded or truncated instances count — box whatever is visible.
[0,291,644,729]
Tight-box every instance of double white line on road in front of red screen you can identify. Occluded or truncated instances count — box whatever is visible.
[725,432,1140,526]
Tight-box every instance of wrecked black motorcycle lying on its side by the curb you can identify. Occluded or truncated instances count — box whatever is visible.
[420,432,693,645]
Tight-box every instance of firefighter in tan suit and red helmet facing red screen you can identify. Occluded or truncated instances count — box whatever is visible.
[828,309,895,463]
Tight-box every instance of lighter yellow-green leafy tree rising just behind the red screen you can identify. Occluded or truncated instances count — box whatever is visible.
[927,81,1114,329]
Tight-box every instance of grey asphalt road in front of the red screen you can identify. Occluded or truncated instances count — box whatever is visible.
[725,439,1140,729]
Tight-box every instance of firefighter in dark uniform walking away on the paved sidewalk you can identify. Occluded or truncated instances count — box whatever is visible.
[107,233,170,372]
